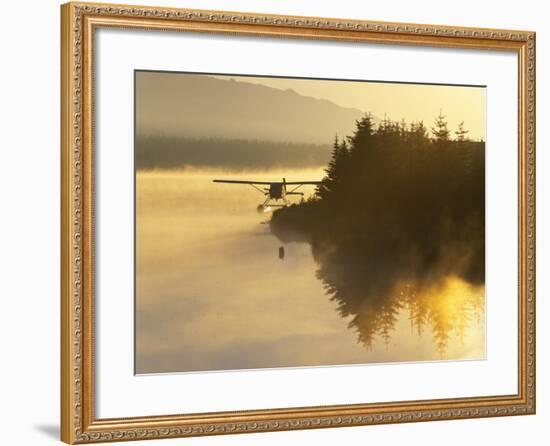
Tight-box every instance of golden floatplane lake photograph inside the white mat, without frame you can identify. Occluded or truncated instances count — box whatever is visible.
[134,70,486,374]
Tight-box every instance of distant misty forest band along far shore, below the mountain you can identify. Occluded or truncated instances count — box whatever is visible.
[135,134,331,170]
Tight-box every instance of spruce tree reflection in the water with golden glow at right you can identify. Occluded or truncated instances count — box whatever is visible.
[313,240,485,358]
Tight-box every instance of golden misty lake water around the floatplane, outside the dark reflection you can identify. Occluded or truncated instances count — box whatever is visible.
[136,168,485,373]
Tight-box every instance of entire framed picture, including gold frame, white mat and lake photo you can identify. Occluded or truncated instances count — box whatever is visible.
[60,6,536,444]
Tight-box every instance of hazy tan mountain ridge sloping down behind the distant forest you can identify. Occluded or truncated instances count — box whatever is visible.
[135,72,364,144]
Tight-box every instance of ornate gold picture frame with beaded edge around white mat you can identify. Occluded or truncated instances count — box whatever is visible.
[61,2,535,444]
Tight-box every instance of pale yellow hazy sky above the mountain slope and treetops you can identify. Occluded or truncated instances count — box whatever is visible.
[216,76,486,140]
